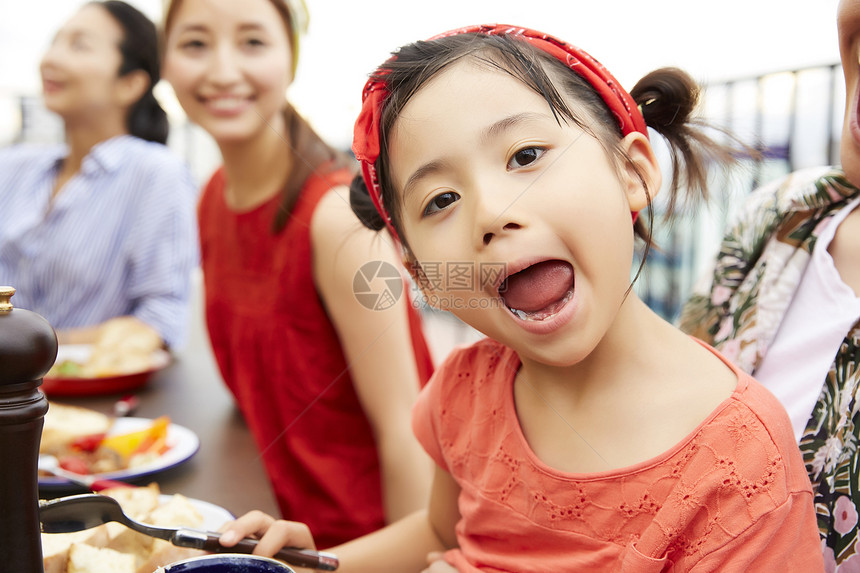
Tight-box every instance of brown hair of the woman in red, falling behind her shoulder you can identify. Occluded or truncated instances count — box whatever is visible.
[272,104,358,233]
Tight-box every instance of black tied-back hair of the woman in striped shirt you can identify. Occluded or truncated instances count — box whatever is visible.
[97,0,170,143]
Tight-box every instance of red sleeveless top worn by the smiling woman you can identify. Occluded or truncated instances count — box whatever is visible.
[199,165,432,547]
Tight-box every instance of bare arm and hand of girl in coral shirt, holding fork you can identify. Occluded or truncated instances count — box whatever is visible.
[221,467,460,573]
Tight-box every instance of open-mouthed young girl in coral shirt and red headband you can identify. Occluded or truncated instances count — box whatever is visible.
[215,26,822,572]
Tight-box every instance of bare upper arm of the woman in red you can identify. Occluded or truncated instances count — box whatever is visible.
[311,188,431,523]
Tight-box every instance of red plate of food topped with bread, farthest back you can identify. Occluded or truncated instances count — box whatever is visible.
[42,317,170,396]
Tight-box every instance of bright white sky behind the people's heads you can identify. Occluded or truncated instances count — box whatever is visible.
[0,0,839,149]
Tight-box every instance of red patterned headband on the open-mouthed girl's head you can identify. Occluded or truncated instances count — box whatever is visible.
[352,24,648,239]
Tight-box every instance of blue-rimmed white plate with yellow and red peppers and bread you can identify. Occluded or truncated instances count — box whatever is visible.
[39,402,200,488]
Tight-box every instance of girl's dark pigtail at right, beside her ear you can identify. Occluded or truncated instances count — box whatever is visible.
[630,68,744,218]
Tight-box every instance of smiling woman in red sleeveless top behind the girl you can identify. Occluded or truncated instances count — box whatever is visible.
[164,0,431,545]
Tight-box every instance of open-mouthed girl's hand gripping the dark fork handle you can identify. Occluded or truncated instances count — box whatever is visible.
[220,510,316,557]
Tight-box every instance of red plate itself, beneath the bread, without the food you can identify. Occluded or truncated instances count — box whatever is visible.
[41,344,170,396]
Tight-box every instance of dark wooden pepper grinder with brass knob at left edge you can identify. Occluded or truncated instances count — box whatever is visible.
[0,286,57,573]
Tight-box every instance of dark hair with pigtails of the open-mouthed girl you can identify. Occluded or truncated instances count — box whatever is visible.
[350,33,733,252]
